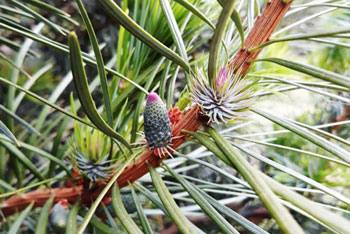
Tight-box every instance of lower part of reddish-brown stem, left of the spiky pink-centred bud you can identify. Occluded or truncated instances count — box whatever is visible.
[1,106,200,217]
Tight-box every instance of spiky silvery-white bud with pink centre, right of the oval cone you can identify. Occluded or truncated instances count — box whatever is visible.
[191,67,254,123]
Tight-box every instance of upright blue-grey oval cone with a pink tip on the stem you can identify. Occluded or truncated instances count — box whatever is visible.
[143,93,171,148]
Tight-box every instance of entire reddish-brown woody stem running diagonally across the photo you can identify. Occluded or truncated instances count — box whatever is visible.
[1,0,291,217]
